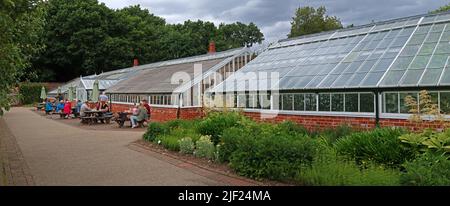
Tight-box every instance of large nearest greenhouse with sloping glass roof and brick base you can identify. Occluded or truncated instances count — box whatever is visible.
[209,12,450,127]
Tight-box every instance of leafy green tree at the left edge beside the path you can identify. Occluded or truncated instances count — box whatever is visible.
[0,0,43,115]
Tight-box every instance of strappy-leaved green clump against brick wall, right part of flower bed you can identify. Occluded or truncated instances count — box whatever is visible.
[335,128,414,167]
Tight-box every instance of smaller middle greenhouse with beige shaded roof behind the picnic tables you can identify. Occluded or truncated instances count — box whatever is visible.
[106,48,254,119]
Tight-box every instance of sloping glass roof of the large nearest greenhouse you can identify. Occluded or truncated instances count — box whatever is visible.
[213,13,450,92]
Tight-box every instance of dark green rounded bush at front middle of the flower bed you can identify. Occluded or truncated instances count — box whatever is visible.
[230,134,318,180]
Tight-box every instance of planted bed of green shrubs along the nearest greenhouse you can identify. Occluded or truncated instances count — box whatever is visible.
[144,112,450,185]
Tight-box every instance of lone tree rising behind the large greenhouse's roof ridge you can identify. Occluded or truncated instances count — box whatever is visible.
[288,6,342,38]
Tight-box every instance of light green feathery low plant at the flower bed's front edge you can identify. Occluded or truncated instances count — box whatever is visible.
[296,147,400,186]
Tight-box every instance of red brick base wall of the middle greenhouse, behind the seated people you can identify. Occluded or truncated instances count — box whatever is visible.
[111,103,203,122]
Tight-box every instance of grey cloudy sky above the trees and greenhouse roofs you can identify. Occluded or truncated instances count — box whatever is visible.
[99,0,450,41]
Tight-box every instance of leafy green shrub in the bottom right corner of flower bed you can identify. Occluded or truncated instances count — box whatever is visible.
[400,152,450,186]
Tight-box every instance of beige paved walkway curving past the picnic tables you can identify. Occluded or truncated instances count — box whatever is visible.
[0,108,251,185]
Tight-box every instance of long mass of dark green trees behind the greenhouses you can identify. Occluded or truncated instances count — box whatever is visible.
[29,0,264,81]
